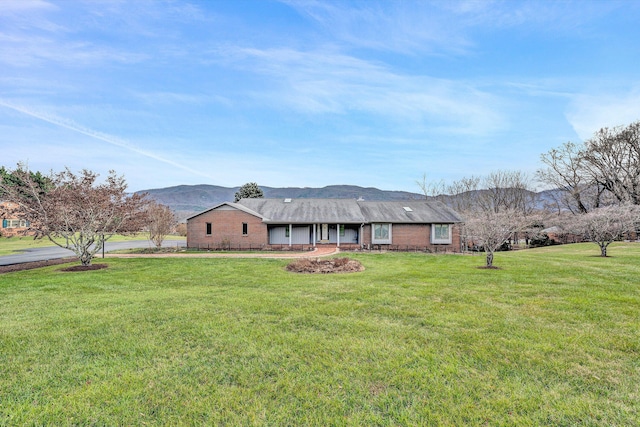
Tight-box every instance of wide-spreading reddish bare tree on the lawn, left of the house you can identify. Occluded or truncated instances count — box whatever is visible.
[0,168,147,265]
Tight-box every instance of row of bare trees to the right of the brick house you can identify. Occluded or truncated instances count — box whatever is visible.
[417,121,640,267]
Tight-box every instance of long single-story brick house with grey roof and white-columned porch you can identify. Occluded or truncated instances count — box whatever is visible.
[187,198,462,252]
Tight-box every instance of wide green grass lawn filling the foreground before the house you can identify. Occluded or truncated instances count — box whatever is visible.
[0,244,640,426]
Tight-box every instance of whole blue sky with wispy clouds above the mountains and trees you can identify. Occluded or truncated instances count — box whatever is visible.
[0,0,640,192]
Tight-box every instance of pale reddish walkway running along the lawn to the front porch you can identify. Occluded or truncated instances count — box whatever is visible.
[106,245,340,260]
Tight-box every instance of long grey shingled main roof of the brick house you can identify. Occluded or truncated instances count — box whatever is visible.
[232,199,462,224]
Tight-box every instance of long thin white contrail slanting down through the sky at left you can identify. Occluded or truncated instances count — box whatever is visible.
[0,99,211,178]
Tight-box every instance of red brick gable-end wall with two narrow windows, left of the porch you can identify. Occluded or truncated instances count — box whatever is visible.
[187,209,268,249]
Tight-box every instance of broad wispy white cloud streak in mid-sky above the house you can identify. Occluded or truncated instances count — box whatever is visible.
[216,48,503,133]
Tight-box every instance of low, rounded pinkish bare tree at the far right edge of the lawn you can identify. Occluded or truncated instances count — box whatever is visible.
[565,205,640,257]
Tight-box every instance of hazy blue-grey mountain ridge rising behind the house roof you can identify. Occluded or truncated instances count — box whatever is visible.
[138,184,424,220]
